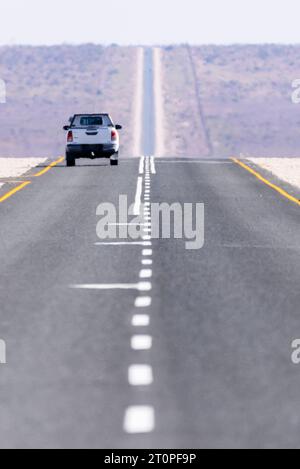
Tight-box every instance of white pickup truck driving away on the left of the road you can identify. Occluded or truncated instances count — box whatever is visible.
[64,114,122,166]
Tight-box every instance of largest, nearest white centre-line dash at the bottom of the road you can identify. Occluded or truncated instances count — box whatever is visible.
[124,406,155,435]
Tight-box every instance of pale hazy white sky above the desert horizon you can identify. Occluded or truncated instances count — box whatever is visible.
[0,0,300,44]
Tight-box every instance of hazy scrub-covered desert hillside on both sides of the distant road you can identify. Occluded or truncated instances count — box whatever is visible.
[0,44,300,158]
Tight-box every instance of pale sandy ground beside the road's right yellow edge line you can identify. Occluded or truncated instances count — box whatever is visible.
[248,158,300,188]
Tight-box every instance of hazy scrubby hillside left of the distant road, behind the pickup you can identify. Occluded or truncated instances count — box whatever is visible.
[0,44,136,157]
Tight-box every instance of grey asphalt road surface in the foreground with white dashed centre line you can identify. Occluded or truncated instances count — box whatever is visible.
[0,49,300,448]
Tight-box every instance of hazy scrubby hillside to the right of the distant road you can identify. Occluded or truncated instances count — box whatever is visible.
[163,45,300,156]
